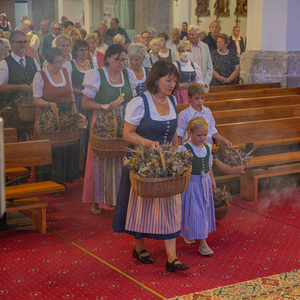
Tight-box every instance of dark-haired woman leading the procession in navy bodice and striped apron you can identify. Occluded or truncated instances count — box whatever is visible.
[113,61,189,272]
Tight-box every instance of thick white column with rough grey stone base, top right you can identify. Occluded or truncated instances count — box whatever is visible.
[240,0,300,87]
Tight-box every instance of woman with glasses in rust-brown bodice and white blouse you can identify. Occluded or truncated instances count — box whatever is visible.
[33,48,79,183]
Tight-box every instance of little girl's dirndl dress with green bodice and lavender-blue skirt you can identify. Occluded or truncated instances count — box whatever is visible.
[180,143,216,240]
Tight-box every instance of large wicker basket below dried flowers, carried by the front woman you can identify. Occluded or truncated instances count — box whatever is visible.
[129,166,192,198]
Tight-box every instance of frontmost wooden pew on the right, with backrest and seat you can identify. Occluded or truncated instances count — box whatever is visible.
[217,117,300,201]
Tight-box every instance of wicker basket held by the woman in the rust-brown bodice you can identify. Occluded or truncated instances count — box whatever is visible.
[38,129,80,148]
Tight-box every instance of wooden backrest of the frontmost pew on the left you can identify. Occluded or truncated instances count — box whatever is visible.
[4,140,52,168]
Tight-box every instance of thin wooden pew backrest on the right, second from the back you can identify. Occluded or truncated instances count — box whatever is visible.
[205,87,300,101]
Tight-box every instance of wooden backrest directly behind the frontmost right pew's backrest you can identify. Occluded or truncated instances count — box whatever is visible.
[213,104,300,125]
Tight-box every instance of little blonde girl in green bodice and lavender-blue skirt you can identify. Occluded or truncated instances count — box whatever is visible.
[180,117,216,255]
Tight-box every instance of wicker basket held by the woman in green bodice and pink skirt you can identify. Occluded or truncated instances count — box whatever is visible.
[89,130,128,158]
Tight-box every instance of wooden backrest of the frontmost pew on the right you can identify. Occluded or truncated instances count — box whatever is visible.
[216,117,300,145]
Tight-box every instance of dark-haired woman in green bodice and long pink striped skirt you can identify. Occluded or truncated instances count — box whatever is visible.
[82,44,137,214]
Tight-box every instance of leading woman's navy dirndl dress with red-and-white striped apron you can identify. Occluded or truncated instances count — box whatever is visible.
[112,94,181,240]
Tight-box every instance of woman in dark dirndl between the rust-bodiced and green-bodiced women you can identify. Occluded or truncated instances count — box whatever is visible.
[66,40,94,170]
